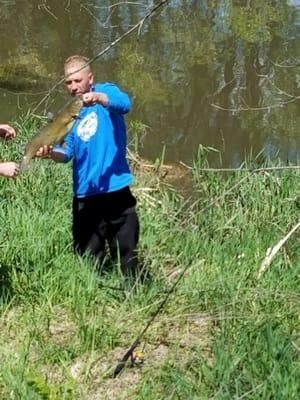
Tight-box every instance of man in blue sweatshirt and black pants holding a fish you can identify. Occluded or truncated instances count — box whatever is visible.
[37,55,139,277]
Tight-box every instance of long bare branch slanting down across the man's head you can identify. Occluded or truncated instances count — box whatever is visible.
[33,0,170,112]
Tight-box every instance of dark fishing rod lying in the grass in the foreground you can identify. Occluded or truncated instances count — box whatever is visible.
[112,264,191,378]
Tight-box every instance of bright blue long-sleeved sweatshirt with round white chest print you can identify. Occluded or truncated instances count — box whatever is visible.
[55,83,133,198]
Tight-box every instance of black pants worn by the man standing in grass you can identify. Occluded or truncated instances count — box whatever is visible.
[73,187,139,275]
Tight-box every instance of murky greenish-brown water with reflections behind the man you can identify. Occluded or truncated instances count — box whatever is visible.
[0,0,300,166]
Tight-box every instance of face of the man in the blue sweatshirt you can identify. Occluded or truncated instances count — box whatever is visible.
[65,65,94,97]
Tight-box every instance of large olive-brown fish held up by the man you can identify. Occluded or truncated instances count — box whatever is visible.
[20,97,83,171]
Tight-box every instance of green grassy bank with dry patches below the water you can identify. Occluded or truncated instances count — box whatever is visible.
[0,114,300,400]
